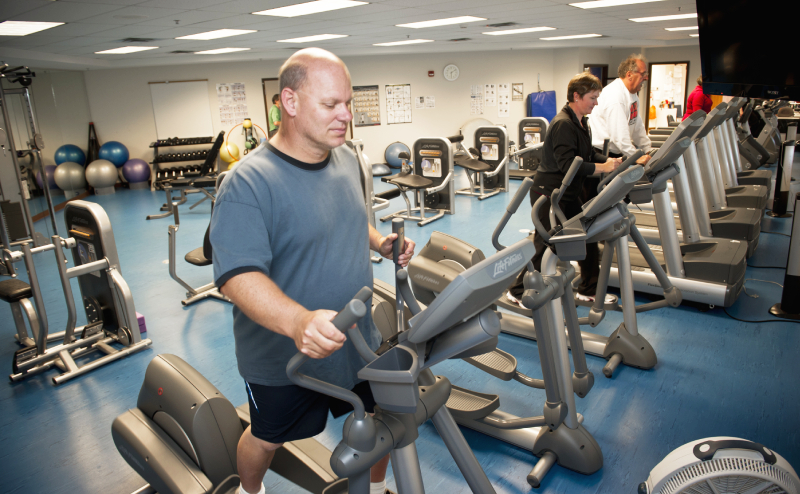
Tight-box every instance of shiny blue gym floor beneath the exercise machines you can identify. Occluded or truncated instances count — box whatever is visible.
[0,160,800,494]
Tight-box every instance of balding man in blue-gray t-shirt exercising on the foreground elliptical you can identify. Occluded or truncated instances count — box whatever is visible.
[210,48,414,494]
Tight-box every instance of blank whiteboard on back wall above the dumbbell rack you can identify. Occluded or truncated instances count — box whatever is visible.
[150,81,214,139]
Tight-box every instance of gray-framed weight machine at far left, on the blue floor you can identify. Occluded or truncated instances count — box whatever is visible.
[0,201,152,384]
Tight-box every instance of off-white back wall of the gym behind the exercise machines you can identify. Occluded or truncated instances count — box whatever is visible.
[84,47,700,162]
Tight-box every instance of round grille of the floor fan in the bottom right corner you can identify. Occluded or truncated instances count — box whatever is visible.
[659,458,797,494]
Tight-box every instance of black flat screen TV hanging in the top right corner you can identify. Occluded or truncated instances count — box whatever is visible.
[697,0,800,100]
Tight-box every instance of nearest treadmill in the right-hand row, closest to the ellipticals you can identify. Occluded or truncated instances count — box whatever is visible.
[609,111,747,307]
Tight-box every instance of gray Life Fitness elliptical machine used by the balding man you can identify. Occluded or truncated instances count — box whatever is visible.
[112,222,534,494]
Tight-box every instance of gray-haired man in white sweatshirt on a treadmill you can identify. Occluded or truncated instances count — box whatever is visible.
[589,55,652,163]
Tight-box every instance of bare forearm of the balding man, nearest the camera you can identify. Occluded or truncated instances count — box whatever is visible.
[219,271,308,338]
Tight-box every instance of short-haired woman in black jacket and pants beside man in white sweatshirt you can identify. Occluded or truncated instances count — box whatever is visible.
[509,72,621,305]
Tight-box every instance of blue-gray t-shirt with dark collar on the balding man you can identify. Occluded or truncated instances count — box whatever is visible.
[210,143,380,389]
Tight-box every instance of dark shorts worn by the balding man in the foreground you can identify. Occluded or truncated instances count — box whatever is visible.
[245,381,375,444]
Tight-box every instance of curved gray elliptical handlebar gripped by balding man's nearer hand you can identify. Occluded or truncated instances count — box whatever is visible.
[286,287,374,419]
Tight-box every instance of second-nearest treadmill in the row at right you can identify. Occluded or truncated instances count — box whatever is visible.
[634,110,762,257]
